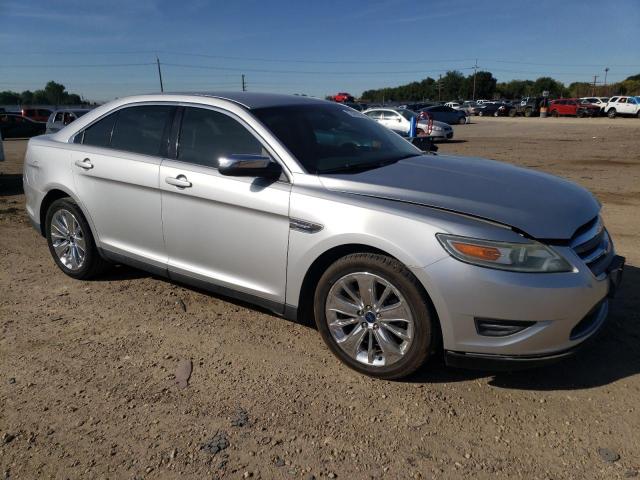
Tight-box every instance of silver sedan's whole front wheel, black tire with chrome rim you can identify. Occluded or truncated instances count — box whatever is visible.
[313,253,439,379]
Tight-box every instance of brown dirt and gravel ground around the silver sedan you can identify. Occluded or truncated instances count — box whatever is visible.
[0,118,640,479]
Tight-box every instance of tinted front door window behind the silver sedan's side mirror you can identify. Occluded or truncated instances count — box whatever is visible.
[178,108,268,167]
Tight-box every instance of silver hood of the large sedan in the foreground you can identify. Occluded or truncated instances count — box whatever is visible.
[320,155,600,240]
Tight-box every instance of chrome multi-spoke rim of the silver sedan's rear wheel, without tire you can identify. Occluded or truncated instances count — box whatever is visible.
[50,208,87,271]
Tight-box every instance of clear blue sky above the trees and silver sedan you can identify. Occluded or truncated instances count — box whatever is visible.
[0,0,640,100]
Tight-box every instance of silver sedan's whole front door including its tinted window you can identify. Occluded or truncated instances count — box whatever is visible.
[160,107,291,309]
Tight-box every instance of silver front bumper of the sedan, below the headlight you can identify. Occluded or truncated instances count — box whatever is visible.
[412,249,624,370]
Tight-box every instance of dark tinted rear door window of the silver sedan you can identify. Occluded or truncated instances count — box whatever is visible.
[111,105,175,155]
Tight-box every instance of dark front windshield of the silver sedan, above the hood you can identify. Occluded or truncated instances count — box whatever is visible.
[253,104,421,173]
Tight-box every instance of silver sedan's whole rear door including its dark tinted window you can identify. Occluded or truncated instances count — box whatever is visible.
[72,105,176,271]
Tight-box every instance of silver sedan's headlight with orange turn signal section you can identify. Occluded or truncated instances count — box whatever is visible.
[436,233,573,273]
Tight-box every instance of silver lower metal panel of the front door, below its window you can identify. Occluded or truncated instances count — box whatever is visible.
[160,160,291,303]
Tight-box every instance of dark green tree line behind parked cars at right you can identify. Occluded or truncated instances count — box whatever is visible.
[361,70,640,102]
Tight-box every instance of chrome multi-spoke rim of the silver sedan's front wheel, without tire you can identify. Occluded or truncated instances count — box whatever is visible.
[325,272,415,367]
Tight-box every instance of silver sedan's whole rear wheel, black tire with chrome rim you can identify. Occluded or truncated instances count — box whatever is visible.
[45,197,108,280]
